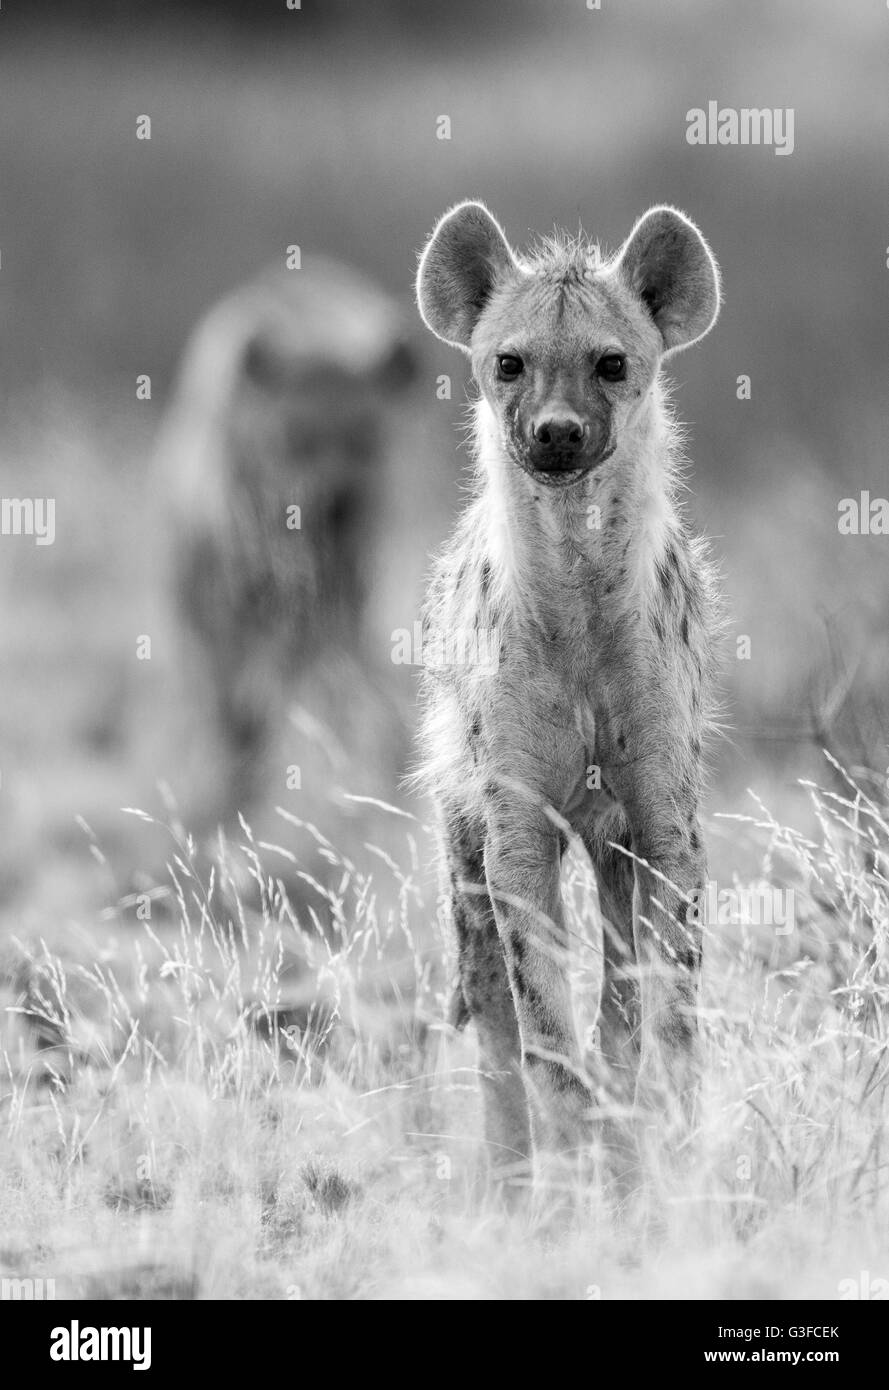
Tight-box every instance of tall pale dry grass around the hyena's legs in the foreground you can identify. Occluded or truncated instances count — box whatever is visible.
[0,756,889,1298]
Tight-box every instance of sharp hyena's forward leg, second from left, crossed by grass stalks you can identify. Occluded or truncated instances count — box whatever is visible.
[485,817,592,1152]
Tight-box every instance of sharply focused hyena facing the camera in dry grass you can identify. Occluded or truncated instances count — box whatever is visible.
[417,203,720,1168]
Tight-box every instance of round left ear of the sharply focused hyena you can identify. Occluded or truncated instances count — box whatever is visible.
[417,203,517,352]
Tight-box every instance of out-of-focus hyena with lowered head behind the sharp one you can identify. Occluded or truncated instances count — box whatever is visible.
[160,257,415,827]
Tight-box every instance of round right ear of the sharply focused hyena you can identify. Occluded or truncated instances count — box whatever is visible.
[614,207,720,352]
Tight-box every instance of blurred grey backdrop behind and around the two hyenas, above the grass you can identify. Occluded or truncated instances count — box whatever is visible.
[0,0,889,931]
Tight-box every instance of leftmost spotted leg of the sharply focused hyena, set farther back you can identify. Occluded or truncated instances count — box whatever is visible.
[449,844,531,1183]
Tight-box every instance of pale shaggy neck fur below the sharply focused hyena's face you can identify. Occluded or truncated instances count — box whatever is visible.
[475,386,683,627]
